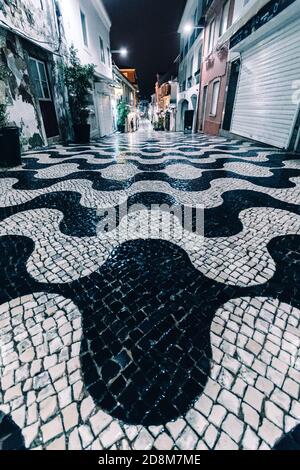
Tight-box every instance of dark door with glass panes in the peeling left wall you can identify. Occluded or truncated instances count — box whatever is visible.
[29,57,59,138]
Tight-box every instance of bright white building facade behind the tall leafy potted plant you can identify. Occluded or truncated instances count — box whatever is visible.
[59,0,114,137]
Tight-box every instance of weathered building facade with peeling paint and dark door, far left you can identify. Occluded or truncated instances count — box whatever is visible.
[0,0,72,150]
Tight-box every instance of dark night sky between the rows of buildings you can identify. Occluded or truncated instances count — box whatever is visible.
[103,0,186,98]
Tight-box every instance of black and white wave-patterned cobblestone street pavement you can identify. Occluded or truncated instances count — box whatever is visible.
[0,126,300,450]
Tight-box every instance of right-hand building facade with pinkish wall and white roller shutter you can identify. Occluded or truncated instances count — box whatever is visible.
[197,0,300,151]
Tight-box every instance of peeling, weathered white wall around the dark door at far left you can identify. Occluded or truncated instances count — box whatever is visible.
[0,0,71,150]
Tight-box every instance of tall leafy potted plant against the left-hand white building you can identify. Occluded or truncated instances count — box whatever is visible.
[64,47,95,144]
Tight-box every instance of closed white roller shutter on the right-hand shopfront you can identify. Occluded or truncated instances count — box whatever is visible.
[231,18,300,148]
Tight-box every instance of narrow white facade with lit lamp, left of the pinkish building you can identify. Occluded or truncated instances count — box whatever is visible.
[176,0,203,131]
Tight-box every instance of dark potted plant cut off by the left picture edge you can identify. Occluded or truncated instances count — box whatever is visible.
[0,65,21,168]
